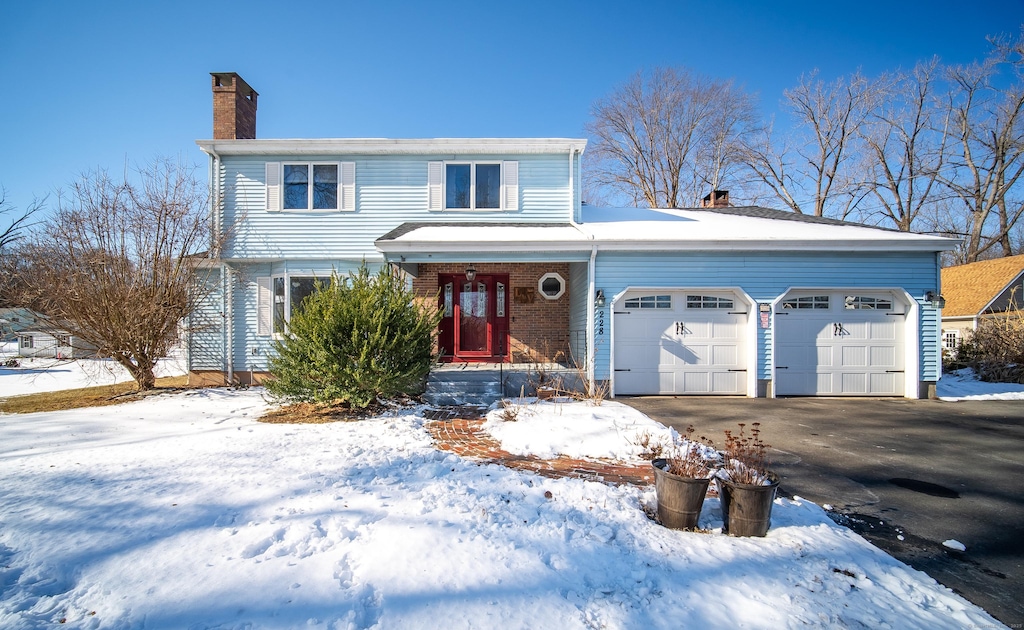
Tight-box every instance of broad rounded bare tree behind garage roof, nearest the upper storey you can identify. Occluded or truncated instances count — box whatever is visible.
[586,68,757,208]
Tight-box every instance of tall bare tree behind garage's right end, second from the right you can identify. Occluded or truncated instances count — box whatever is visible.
[858,57,949,232]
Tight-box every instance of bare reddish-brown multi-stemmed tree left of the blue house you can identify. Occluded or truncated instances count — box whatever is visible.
[23,161,218,389]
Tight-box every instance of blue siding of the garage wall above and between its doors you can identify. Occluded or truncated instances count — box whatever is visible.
[595,251,939,381]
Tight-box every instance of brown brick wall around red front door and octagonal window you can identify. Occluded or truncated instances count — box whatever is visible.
[413,262,572,364]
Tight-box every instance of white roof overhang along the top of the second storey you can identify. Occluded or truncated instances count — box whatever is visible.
[196,138,587,156]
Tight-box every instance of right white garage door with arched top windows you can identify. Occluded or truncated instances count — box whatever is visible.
[774,291,906,396]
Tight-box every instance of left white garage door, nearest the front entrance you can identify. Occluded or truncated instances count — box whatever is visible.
[612,290,749,394]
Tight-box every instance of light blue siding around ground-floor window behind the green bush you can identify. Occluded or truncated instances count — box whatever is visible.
[231,260,380,372]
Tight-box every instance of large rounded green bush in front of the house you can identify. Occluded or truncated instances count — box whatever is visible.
[266,265,440,409]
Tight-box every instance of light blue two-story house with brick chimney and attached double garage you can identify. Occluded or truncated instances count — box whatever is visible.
[189,73,955,397]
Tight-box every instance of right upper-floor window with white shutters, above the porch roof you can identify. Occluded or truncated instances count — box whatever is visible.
[427,161,519,211]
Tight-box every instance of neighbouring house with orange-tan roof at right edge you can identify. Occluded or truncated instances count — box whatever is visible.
[942,254,1024,351]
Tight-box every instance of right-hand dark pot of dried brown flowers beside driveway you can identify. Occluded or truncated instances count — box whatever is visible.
[715,422,778,536]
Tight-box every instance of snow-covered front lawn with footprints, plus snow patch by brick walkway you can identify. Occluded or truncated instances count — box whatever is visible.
[0,389,998,630]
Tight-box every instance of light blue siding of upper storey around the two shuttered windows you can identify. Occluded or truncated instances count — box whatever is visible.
[220,155,573,261]
